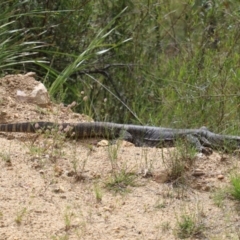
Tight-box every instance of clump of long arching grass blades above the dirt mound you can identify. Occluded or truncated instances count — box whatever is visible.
[0,1,46,75]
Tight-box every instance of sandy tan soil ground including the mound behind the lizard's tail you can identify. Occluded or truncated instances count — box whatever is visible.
[0,74,240,240]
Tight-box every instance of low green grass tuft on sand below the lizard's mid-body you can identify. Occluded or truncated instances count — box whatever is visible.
[105,169,137,193]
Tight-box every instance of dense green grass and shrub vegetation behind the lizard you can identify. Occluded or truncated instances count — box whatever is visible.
[0,0,240,134]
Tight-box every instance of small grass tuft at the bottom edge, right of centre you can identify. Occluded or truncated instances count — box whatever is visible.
[173,214,204,239]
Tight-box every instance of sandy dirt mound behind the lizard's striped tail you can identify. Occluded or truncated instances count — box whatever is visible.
[0,73,91,123]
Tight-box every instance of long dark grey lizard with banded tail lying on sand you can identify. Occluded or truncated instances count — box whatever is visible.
[0,122,240,154]
